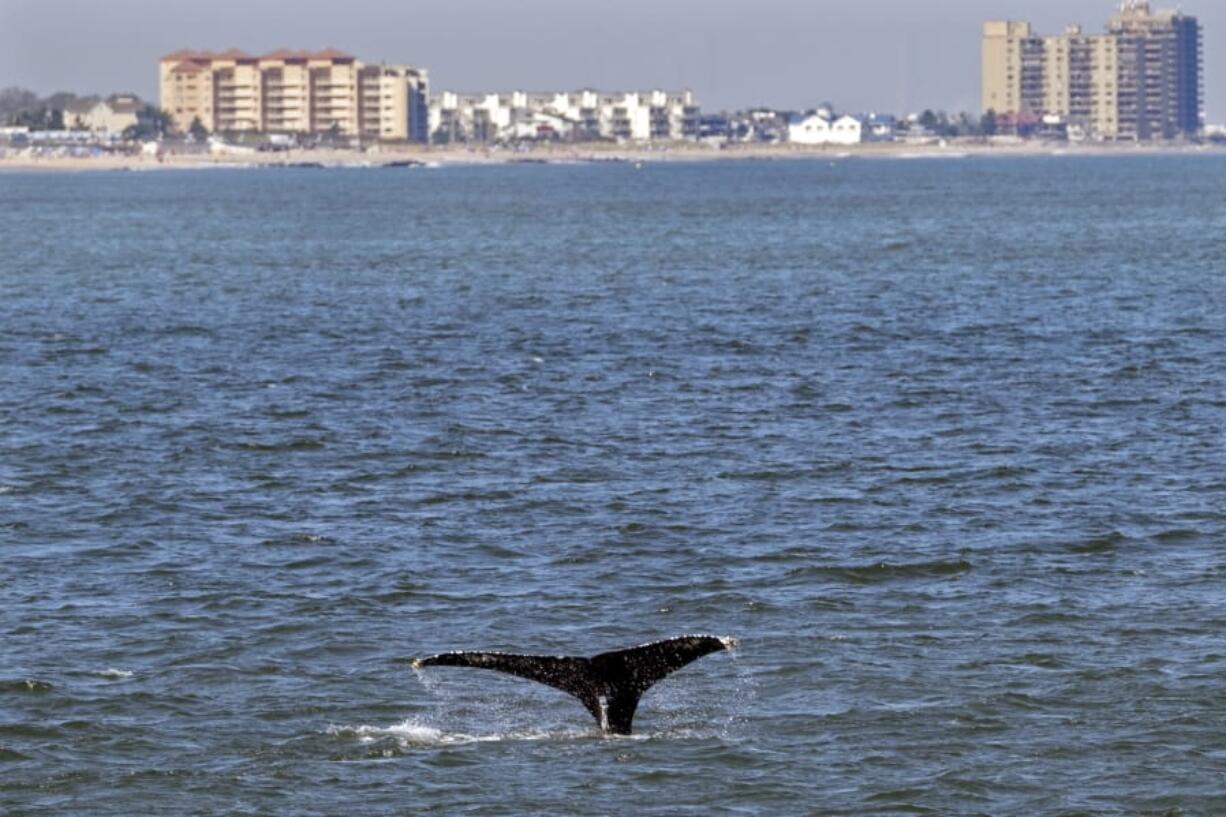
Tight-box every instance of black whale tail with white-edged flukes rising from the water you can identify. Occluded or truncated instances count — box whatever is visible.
[413,635,737,735]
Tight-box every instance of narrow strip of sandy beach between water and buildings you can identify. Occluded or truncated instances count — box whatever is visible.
[0,141,1226,172]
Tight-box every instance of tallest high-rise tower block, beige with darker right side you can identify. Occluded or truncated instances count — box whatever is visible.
[982,0,1204,140]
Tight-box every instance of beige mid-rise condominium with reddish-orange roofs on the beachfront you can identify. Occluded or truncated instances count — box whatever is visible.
[159,49,429,142]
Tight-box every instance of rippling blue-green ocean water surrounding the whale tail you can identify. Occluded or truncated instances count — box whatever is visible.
[0,157,1226,816]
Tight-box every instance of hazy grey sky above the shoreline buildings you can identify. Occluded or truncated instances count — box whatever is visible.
[0,0,1226,123]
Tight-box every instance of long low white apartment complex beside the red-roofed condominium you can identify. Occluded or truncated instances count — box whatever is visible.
[430,90,701,142]
